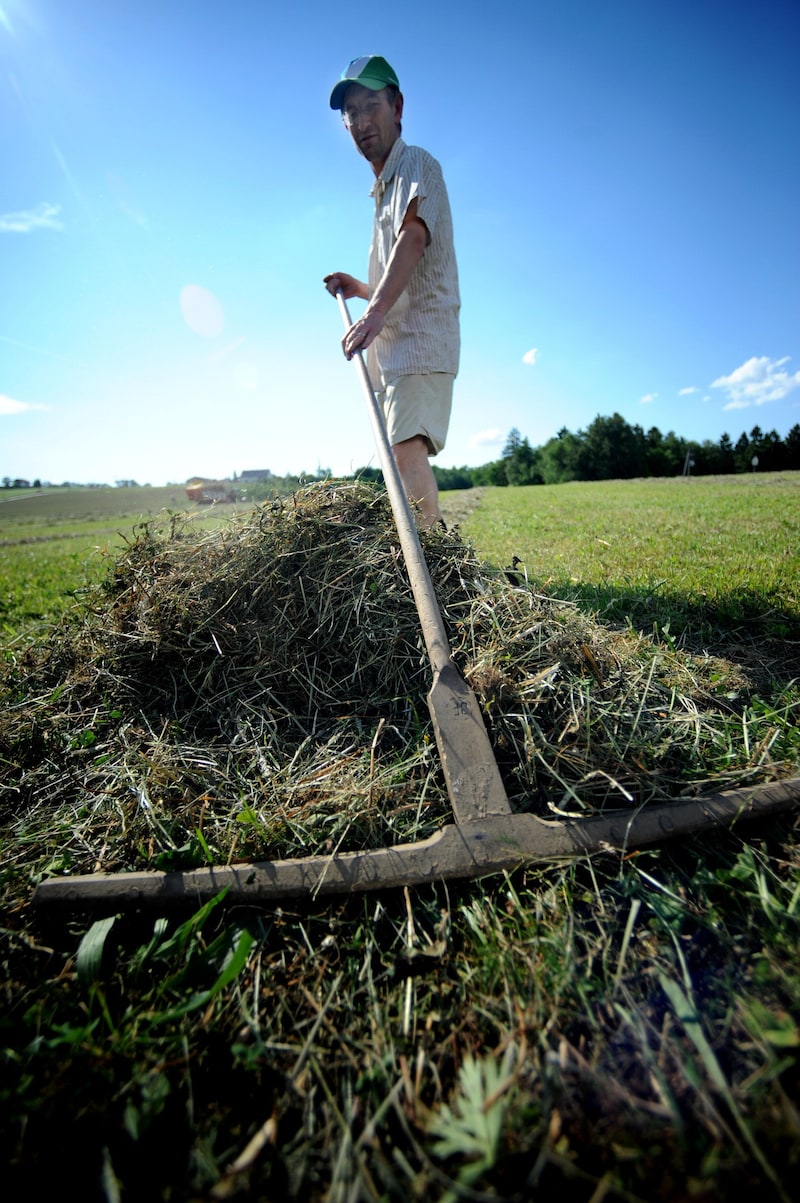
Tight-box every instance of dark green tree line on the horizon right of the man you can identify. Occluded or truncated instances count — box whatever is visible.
[433,414,800,490]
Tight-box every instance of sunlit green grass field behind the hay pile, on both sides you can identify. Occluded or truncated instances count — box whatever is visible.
[6,473,800,640]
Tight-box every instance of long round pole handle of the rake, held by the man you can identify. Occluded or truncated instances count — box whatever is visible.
[336,289,451,672]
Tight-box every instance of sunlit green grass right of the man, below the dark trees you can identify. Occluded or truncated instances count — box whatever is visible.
[444,473,800,641]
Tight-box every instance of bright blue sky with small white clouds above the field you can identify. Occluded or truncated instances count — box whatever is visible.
[0,0,800,485]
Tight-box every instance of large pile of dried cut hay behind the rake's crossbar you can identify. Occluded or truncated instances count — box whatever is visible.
[0,482,776,895]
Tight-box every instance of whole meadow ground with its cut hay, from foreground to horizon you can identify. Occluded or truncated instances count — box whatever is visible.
[0,473,800,1203]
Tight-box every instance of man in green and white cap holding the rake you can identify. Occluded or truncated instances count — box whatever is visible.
[324,54,461,527]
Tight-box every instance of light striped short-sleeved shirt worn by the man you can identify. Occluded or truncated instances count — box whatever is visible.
[367,138,461,383]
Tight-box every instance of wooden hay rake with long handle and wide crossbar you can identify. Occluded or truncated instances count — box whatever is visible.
[34,292,800,907]
